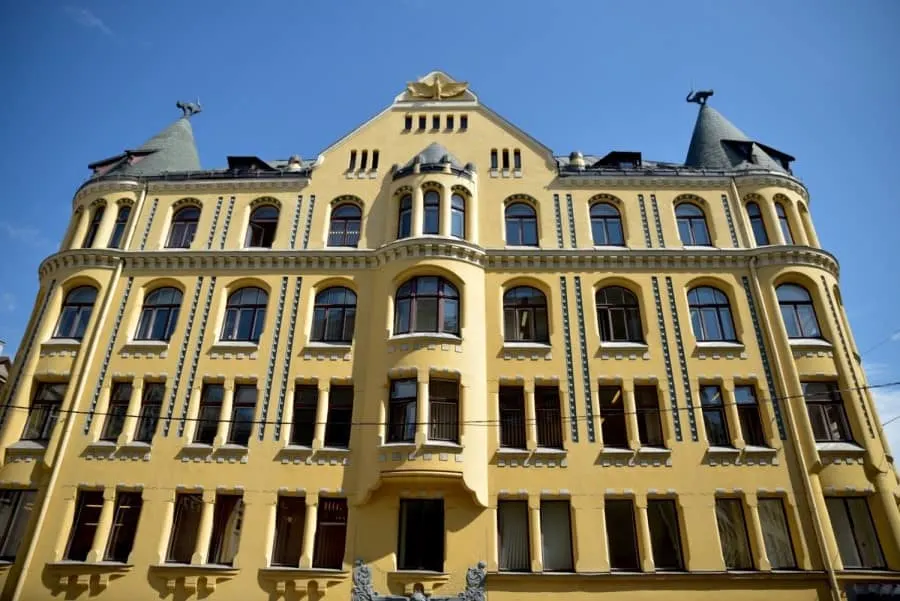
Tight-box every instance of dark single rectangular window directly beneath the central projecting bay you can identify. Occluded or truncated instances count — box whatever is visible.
[397,499,444,572]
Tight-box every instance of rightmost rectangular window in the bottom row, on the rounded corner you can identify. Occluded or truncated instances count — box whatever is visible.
[825,497,885,569]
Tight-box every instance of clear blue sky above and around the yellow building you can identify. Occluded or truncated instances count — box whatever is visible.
[0,0,900,426]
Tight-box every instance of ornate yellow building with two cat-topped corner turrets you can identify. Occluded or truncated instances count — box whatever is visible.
[0,72,900,601]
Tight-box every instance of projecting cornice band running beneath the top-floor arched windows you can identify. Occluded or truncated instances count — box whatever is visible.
[38,238,840,279]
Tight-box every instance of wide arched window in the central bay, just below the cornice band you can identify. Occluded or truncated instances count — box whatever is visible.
[394,276,459,335]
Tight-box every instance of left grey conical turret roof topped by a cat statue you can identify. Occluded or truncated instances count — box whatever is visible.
[88,102,200,177]
